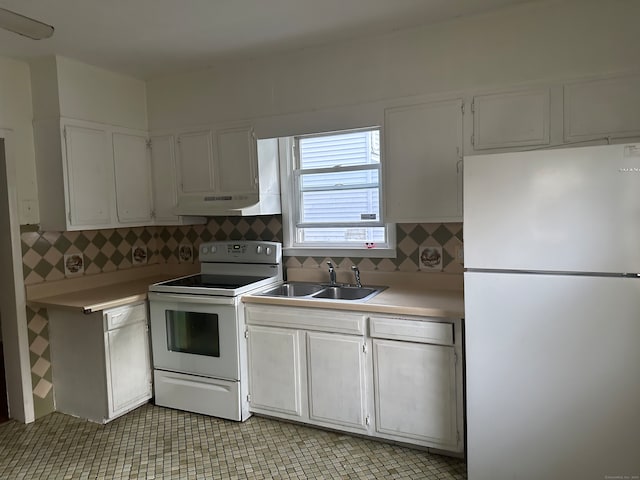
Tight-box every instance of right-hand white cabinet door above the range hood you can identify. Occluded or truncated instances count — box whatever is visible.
[216,127,258,193]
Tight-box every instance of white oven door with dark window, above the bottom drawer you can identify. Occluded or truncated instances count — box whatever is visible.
[149,292,240,381]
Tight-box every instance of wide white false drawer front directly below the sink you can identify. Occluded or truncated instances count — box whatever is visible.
[245,305,366,335]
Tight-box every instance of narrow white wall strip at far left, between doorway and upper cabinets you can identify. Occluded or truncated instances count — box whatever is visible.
[0,57,38,223]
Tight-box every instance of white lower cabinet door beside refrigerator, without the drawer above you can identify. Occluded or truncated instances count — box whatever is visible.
[373,340,458,449]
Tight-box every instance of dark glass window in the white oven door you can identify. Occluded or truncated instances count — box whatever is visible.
[165,310,220,357]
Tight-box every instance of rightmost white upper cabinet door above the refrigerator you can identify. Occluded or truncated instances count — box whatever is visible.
[564,75,640,141]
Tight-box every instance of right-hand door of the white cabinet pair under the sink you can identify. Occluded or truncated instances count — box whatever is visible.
[307,332,368,431]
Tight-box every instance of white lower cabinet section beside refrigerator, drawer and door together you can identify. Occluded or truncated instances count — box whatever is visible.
[369,315,464,452]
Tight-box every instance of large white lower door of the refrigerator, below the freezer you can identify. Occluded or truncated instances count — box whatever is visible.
[465,272,640,480]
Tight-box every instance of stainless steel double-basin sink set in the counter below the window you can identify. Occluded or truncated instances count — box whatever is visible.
[258,282,387,302]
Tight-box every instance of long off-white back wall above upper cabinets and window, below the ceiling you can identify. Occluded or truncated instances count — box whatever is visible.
[147,0,640,134]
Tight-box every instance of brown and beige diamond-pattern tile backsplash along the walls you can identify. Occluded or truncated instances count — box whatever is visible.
[21,215,462,418]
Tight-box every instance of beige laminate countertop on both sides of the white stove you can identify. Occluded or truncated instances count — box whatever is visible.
[26,264,464,318]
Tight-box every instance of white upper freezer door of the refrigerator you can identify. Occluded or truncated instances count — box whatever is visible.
[464,144,640,273]
